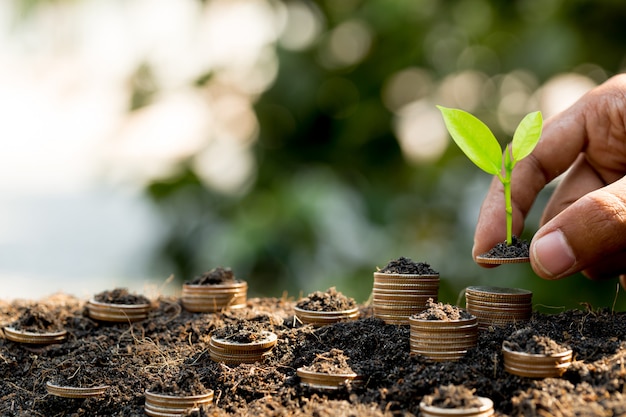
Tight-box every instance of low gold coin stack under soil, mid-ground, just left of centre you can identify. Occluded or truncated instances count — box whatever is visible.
[209,331,278,365]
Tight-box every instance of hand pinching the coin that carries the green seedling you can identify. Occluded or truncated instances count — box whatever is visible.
[473,74,626,285]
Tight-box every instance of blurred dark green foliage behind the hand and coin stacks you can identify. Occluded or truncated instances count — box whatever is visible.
[144,0,626,311]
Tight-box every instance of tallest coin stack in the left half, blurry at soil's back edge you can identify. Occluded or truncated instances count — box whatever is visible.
[182,281,248,313]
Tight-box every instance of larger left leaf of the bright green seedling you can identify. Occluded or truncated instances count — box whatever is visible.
[437,106,502,175]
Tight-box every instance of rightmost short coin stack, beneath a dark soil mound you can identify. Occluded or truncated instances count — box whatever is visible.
[502,346,573,378]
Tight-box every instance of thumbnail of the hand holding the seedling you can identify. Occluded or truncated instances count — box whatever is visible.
[533,229,576,278]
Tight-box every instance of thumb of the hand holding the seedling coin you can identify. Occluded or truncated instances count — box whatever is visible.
[530,178,626,279]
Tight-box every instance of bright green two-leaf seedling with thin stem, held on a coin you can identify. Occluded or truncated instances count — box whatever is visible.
[437,106,543,246]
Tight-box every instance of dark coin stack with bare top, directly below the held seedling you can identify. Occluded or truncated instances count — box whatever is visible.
[465,286,533,330]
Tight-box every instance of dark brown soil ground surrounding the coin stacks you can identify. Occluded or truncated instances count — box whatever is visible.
[0,295,626,417]
